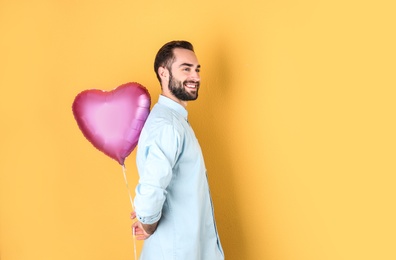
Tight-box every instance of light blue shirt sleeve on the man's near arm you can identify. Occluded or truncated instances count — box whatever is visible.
[134,125,181,224]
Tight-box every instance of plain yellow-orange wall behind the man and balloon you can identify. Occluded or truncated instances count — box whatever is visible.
[0,0,396,260]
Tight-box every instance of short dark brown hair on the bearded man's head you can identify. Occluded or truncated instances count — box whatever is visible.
[154,41,194,83]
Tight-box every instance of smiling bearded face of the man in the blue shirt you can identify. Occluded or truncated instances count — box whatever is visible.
[168,48,200,101]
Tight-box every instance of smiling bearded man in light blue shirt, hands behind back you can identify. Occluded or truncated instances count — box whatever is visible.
[132,41,224,260]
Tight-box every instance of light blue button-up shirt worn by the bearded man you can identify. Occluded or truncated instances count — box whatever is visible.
[134,96,224,260]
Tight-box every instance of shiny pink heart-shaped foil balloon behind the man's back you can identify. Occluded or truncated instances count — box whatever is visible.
[72,82,151,165]
